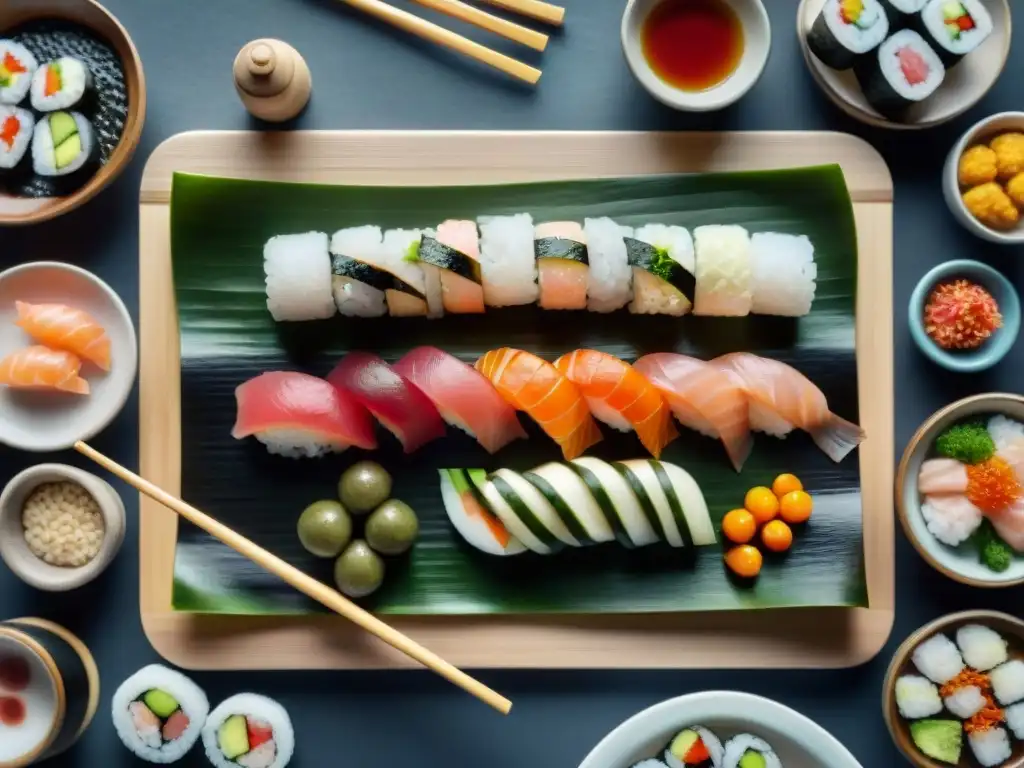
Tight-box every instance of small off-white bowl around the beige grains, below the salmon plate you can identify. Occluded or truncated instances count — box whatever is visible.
[0,464,125,592]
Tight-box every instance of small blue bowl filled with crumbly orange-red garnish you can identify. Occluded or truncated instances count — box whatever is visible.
[908,259,1021,373]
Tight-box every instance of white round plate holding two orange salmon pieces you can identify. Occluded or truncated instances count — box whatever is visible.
[0,261,138,452]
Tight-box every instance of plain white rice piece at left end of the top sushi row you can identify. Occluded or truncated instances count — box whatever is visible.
[262,231,338,323]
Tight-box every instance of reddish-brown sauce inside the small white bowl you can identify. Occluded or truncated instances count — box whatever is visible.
[640,0,743,91]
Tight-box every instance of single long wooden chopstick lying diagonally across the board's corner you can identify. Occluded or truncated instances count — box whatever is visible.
[75,440,512,715]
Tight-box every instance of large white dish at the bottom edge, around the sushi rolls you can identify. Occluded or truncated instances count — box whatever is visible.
[580,691,862,768]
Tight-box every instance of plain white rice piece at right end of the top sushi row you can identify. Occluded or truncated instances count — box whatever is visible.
[751,232,818,317]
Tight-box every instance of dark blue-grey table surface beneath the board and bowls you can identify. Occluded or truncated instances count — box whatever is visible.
[0,0,1024,768]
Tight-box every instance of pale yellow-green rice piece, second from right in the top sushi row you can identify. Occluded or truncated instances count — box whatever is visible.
[693,224,754,317]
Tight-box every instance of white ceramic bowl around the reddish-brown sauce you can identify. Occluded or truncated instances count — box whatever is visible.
[622,0,771,112]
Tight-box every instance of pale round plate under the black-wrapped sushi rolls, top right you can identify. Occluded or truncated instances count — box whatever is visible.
[797,0,1012,130]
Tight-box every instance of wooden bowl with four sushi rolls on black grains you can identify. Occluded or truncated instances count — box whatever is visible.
[0,0,145,225]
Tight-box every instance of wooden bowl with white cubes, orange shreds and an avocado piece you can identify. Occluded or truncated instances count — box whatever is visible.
[882,610,1024,768]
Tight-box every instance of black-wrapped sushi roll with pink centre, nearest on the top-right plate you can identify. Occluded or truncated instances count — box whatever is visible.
[856,30,946,120]
